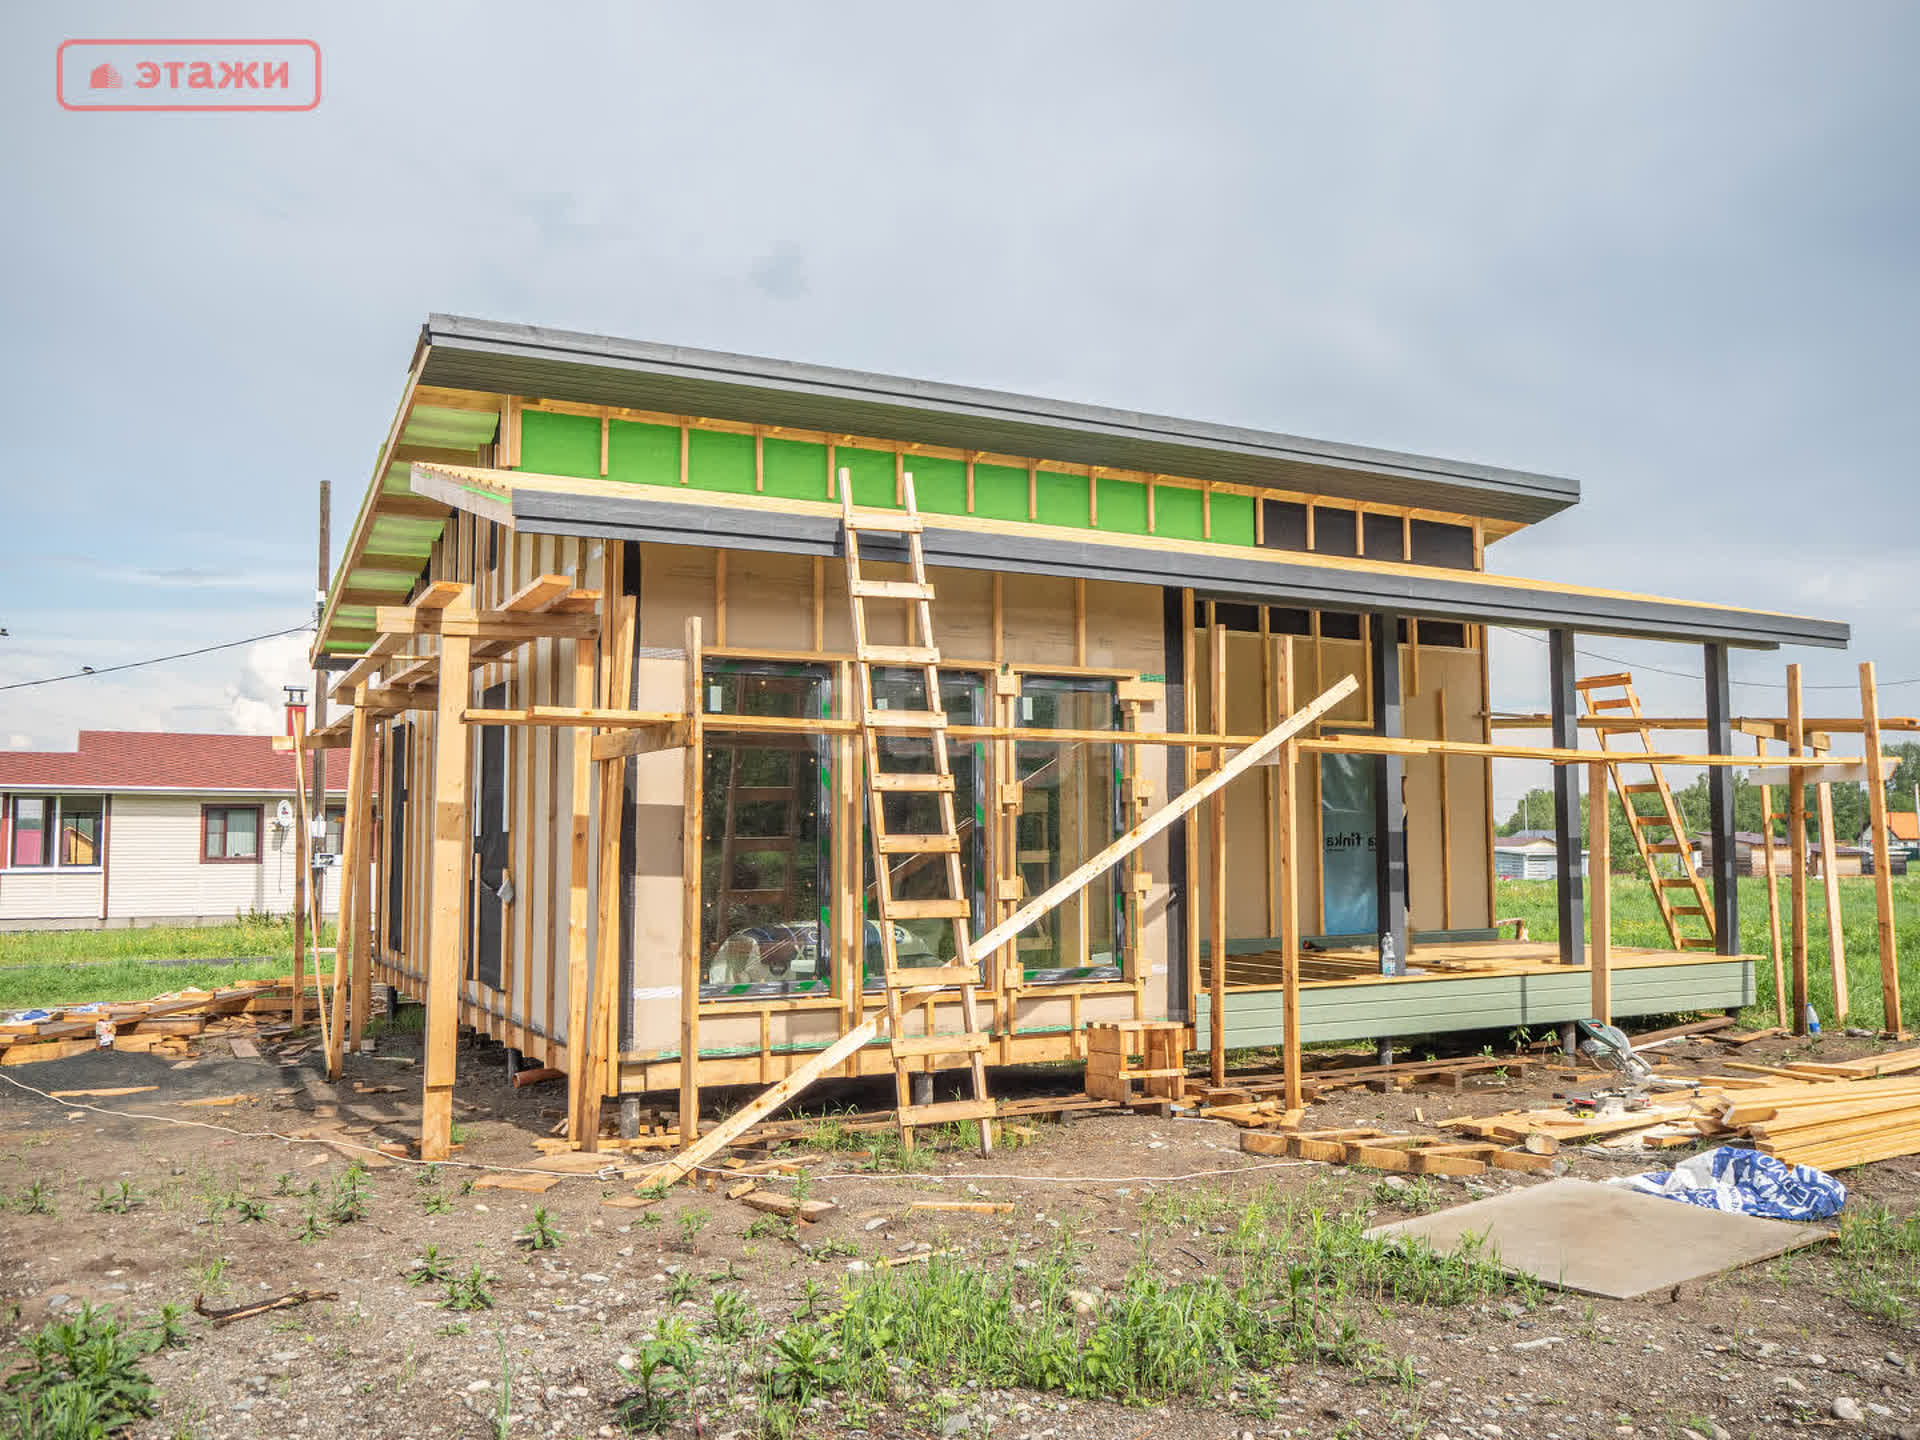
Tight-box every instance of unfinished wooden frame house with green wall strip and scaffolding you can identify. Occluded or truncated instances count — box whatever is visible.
[291,315,1897,1156]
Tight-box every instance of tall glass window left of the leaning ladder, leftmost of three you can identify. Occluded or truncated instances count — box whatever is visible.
[701,660,833,998]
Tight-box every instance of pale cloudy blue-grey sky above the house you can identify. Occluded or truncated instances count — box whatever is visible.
[0,0,1920,806]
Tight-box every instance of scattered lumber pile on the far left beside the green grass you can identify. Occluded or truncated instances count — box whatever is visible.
[0,975,349,1066]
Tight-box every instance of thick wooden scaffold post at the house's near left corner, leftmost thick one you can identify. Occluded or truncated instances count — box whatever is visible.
[420,602,472,1162]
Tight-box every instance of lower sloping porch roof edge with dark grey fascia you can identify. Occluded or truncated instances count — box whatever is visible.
[411,465,1849,649]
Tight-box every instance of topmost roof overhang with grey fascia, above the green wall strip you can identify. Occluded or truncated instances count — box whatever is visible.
[420,315,1580,524]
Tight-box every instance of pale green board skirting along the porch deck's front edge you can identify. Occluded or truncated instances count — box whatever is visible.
[1198,958,1753,1050]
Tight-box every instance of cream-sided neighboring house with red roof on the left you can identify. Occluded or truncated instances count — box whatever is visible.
[0,730,346,929]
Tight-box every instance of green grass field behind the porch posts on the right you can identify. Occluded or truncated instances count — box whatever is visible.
[1494,876,1920,1029]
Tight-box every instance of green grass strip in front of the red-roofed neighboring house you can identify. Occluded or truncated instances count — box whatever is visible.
[0,920,332,1012]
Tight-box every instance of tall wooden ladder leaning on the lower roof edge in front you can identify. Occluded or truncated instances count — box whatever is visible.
[839,470,995,1154]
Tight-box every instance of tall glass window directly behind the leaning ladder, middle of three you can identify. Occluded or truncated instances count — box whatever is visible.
[860,666,987,989]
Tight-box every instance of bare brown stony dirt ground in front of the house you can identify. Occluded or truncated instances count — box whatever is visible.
[0,1033,1920,1440]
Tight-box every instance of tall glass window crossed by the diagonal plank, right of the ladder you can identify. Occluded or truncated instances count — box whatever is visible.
[1014,678,1123,985]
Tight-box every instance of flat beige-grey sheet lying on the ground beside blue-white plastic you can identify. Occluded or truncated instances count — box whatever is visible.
[1367,1179,1834,1300]
